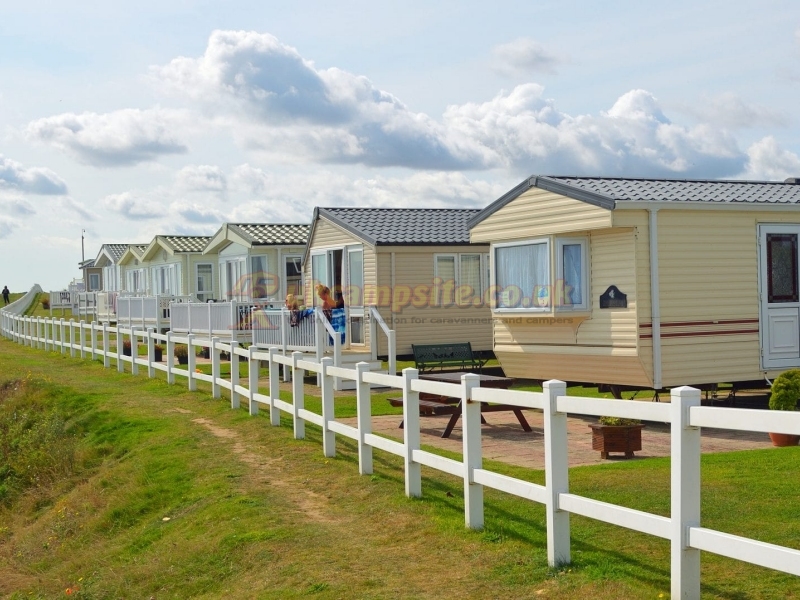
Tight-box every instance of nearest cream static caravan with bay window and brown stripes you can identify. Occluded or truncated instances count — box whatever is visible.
[469,177,800,389]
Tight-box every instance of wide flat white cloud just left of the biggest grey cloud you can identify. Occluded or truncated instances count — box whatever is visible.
[25,108,187,167]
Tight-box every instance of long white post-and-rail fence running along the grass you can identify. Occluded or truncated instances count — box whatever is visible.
[1,294,800,598]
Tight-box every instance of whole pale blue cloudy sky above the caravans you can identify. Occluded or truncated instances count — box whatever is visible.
[0,0,800,290]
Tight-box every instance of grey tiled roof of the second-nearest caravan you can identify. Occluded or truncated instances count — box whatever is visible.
[314,208,480,246]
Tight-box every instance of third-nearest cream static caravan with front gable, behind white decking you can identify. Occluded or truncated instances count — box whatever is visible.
[203,223,310,306]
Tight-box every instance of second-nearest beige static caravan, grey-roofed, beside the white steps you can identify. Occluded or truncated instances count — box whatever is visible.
[303,208,492,355]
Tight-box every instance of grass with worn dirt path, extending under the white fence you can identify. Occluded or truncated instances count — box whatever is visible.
[0,340,800,600]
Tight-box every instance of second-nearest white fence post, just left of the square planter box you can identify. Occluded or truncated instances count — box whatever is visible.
[542,379,572,567]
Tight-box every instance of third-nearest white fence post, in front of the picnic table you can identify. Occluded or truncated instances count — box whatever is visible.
[461,373,483,529]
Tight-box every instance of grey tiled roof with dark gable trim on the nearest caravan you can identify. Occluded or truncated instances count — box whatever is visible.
[469,175,800,228]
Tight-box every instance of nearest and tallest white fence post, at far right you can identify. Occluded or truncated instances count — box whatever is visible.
[670,386,700,598]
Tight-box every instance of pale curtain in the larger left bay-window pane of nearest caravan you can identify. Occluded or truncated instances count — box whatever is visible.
[495,242,550,308]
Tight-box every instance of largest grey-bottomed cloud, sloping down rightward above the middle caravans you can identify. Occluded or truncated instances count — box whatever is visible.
[152,31,479,169]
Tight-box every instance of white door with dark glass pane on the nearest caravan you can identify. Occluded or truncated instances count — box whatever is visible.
[758,225,800,369]
